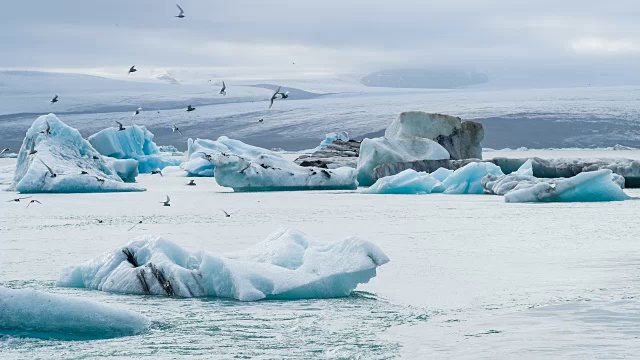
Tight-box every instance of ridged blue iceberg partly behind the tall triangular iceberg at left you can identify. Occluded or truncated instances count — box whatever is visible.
[89,125,180,173]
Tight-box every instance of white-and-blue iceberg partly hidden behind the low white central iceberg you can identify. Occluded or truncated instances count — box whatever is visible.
[180,136,280,176]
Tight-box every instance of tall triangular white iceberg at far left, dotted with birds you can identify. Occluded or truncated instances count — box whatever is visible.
[13,114,144,193]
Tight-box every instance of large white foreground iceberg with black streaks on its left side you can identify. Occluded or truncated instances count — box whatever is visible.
[58,230,389,301]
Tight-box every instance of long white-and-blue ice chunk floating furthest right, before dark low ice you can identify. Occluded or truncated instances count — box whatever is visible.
[483,169,629,202]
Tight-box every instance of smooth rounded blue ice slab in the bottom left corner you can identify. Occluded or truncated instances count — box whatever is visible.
[0,286,149,340]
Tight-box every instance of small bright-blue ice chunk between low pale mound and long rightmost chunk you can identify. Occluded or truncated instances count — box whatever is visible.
[433,162,504,194]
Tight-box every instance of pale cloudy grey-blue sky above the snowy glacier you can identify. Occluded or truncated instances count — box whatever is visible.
[0,0,640,83]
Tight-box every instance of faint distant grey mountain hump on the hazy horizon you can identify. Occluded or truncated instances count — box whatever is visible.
[360,69,489,89]
